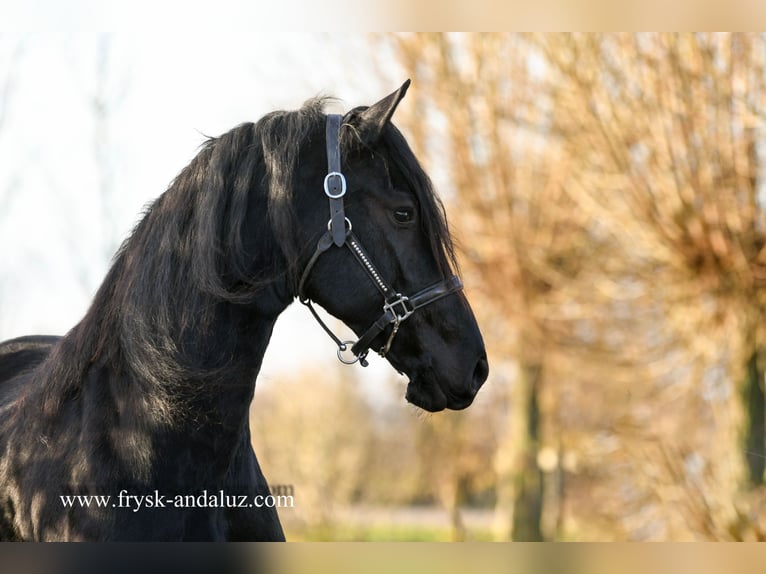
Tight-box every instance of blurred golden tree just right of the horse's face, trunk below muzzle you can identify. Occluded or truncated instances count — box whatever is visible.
[394,34,574,540]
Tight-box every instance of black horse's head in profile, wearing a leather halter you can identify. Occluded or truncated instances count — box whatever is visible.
[298,81,489,412]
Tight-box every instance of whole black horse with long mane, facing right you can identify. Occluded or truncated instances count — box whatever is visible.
[0,82,488,540]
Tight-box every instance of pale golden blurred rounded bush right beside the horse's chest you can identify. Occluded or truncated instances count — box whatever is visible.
[250,366,373,529]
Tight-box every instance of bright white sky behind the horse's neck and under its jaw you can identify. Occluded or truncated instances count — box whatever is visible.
[0,30,412,396]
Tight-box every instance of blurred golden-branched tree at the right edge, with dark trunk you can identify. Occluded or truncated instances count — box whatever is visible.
[535,34,766,485]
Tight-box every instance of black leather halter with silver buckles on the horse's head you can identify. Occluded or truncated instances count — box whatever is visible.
[298,114,463,367]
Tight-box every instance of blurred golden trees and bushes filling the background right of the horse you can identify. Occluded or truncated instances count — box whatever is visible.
[253,33,766,540]
